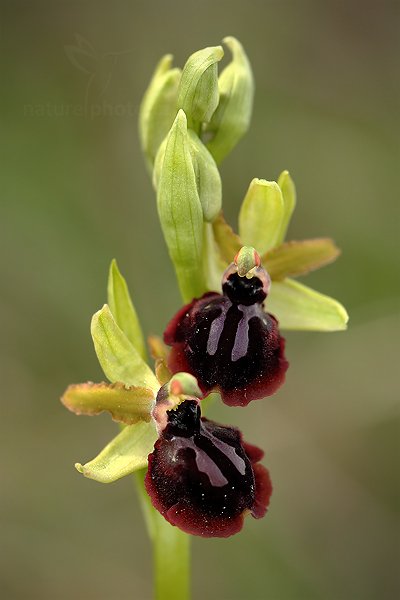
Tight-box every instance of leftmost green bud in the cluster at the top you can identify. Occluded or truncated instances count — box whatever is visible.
[139,54,181,172]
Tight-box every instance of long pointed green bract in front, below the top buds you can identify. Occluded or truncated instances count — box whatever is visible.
[157,110,205,302]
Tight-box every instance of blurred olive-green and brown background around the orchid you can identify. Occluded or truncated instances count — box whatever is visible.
[0,0,400,600]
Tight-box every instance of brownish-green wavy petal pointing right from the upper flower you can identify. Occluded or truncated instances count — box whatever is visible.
[261,238,340,280]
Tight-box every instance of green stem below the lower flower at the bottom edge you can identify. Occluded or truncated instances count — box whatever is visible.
[135,469,190,600]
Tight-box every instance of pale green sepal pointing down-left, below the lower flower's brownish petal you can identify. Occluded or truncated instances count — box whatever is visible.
[75,422,157,483]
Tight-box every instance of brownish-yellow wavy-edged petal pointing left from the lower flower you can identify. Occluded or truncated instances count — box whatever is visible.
[61,382,154,425]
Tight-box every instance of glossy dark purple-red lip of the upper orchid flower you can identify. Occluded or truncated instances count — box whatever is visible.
[164,264,288,406]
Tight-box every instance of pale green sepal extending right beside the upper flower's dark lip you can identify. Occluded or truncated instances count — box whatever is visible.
[265,279,349,331]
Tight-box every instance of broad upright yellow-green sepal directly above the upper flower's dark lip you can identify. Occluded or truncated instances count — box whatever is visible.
[239,179,284,254]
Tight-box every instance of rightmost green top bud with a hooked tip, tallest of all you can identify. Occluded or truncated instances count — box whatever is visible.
[205,37,254,163]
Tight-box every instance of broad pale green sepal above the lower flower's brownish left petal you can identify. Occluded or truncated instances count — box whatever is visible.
[91,304,159,392]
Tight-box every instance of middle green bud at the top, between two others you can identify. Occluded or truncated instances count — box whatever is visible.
[178,46,224,132]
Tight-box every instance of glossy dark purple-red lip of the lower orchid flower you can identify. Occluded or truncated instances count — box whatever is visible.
[145,399,272,537]
